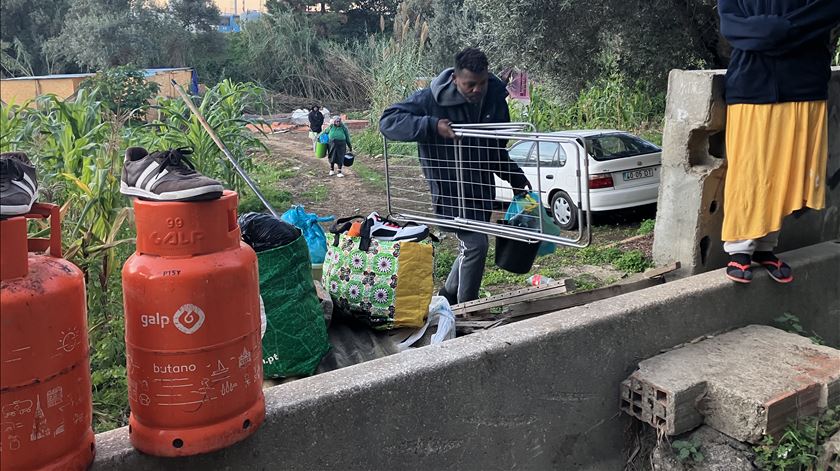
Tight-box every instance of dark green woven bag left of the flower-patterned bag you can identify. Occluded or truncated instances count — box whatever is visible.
[257,236,330,378]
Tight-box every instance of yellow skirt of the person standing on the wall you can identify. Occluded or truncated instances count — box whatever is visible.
[721,101,828,241]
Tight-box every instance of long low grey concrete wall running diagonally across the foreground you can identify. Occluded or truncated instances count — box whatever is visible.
[93,242,840,471]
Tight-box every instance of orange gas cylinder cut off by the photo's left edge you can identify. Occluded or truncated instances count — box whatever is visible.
[0,204,94,471]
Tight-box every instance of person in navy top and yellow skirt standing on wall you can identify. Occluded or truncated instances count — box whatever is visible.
[718,0,840,283]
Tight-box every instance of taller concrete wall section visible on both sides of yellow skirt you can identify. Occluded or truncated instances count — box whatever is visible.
[653,67,840,275]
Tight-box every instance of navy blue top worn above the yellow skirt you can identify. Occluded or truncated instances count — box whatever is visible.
[718,0,840,104]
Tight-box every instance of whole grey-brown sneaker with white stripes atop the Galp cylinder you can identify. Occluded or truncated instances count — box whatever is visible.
[120,147,224,201]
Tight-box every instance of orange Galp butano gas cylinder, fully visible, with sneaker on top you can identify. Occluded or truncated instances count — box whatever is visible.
[122,191,265,456]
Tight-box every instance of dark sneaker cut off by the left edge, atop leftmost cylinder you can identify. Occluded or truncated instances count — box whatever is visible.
[0,152,38,217]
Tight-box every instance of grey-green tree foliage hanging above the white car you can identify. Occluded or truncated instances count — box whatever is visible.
[460,0,720,96]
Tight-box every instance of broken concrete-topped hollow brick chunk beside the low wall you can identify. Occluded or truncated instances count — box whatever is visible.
[621,325,840,443]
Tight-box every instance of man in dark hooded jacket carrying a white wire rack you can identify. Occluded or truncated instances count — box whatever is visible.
[379,48,530,304]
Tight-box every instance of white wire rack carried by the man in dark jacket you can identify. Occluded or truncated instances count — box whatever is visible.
[384,123,591,247]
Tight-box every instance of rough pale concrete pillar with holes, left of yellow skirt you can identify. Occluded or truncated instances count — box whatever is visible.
[653,70,726,276]
